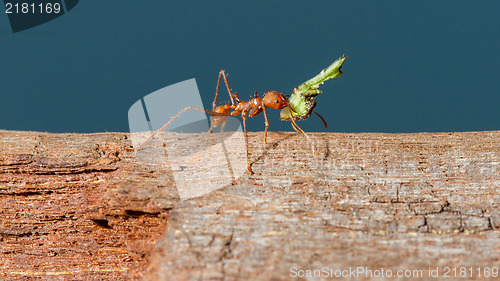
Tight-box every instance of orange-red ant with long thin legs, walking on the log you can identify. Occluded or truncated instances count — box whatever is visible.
[136,70,326,174]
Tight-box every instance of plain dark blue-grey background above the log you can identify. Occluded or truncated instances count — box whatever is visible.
[0,0,500,132]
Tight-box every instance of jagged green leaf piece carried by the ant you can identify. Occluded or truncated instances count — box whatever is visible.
[280,56,347,120]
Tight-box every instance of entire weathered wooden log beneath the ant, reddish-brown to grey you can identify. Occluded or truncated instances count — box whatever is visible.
[0,131,500,280]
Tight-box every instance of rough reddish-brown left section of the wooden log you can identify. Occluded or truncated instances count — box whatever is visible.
[0,131,177,280]
